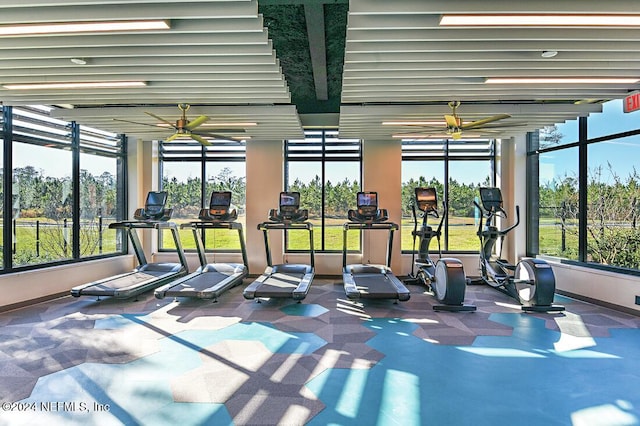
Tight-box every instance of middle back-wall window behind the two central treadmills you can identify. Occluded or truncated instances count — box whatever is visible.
[285,130,362,251]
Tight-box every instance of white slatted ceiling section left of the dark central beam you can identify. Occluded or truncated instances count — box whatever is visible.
[0,0,302,138]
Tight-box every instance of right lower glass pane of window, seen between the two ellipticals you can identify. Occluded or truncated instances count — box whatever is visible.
[446,160,492,251]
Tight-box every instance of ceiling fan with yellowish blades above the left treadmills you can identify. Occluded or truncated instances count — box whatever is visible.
[114,104,244,145]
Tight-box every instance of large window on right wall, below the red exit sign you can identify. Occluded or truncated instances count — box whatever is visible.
[528,100,640,270]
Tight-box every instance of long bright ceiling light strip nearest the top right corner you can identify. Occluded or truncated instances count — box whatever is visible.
[440,13,640,27]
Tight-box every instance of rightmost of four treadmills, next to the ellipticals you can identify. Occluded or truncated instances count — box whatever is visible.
[342,192,410,302]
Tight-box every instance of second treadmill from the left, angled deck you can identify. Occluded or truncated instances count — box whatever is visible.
[154,191,249,302]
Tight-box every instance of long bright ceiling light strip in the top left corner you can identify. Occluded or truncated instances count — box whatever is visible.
[0,20,170,36]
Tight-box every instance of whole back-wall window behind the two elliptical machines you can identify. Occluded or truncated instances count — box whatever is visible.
[402,139,495,251]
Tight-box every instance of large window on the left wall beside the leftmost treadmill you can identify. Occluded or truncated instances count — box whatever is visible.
[2,106,126,270]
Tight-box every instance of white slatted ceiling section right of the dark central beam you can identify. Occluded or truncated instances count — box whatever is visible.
[340,0,640,139]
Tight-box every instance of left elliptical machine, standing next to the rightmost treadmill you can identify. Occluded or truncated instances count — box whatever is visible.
[405,188,476,312]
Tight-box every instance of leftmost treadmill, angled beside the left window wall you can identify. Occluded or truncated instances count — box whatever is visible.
[71,191,189,300]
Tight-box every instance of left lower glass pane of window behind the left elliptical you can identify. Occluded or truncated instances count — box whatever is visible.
[401,161,444,251]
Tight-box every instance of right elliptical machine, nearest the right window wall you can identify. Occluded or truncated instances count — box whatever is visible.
[469,188,565,312]
